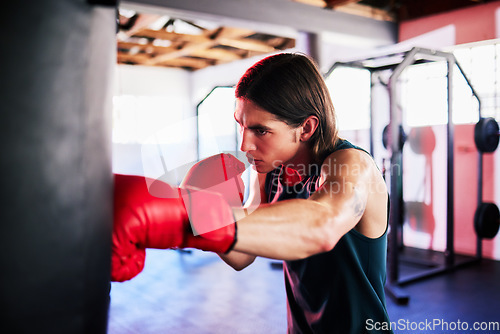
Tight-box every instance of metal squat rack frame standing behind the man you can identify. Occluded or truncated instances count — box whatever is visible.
[326,47,482,304]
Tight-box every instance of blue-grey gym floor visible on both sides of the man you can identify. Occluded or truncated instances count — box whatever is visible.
[108,250,500,334]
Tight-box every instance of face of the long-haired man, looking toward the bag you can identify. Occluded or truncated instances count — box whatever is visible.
[234,98,301,173]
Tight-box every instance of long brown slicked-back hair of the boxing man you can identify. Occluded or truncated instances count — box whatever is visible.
[236,53,338,163]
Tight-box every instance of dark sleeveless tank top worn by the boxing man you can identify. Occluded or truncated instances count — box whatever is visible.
[265,140,392,334]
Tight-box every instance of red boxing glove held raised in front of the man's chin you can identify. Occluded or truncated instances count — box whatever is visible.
[181,153,245,207]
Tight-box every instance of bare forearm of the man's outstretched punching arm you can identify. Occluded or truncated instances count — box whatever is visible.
[234,199,340,260]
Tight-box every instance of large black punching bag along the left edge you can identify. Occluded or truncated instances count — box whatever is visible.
[0,0,116,334]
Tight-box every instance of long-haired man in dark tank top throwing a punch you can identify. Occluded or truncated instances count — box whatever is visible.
[111,54,389,334]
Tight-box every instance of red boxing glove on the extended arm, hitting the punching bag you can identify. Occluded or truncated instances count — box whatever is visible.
[111,175,236,282]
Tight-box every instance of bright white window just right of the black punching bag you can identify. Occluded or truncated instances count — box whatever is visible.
[112,95,196,184]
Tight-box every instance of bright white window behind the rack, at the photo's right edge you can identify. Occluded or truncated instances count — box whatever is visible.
[400,42,500,127]
